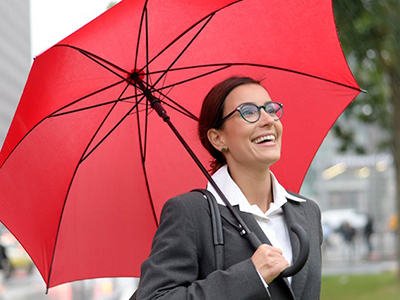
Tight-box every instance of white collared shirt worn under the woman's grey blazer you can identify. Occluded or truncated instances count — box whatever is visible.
[207,165,306,282]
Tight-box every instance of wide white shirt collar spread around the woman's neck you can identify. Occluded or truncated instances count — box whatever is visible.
[207,165,306,217]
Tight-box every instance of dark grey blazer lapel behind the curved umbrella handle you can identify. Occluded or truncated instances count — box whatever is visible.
[282,199,308,299]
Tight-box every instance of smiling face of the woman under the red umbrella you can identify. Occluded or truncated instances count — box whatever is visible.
[217,84,283,170]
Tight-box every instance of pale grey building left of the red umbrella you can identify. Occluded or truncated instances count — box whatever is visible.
[0,0,32,147]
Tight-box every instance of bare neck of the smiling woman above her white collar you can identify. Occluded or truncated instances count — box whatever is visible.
[229,167,273,213]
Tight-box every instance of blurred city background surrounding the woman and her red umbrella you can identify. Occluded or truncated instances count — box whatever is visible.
[0,0,400,300]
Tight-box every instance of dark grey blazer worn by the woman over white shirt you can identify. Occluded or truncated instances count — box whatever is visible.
[137,193,322,300]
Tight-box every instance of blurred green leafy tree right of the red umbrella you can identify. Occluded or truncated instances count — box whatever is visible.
[333,0,400,280]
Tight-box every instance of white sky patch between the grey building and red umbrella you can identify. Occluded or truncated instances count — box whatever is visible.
[30,0,120,57]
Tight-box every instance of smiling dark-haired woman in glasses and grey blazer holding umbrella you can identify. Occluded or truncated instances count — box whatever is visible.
[137,77,322,300]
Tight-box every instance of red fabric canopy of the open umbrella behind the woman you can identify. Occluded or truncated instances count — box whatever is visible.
[0,0,360,287]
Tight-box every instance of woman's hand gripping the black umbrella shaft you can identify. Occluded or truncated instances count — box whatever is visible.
[251,244,289,284]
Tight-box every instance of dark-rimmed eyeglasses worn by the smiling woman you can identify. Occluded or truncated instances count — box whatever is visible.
[217,101,283,127]
